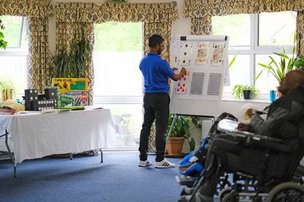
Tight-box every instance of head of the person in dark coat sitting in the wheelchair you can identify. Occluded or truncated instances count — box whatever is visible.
[278,68,304,95]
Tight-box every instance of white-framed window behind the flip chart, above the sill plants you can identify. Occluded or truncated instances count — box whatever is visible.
[212,12,296,94]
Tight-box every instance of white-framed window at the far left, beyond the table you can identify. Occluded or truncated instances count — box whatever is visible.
[0,16,28,98]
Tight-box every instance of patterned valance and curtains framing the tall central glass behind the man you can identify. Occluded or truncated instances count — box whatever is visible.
[56,2,177,103]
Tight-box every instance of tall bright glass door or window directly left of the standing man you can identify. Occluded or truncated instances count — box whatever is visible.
[94,22,143,147]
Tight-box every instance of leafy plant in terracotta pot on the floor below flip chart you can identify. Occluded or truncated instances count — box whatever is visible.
[166,114,195,156]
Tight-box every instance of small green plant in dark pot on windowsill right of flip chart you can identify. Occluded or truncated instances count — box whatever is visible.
[232,84,258,99]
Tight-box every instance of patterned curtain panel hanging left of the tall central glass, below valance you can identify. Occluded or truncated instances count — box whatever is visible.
[56,22,94,105]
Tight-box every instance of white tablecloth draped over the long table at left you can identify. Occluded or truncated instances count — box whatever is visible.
[0,109,116,163]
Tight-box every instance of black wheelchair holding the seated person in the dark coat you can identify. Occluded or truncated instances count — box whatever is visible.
[179,117,304,202]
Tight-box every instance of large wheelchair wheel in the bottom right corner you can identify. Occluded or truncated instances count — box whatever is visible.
[267,182,304,202]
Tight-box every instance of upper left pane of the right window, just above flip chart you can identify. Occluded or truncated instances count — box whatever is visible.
[212,14,250,46]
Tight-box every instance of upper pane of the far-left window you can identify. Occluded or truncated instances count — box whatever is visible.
[0,16,22,48]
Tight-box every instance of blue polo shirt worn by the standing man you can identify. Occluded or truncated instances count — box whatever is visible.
[139,53,174,93]
